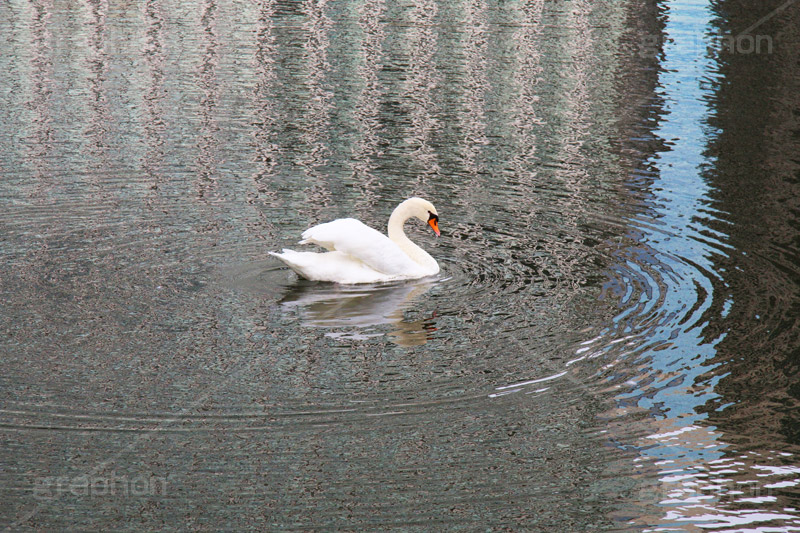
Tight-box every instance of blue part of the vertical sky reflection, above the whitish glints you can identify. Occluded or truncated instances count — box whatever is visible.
[620,1,724,429]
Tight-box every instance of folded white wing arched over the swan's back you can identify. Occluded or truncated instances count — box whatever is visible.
[300,218,420,276]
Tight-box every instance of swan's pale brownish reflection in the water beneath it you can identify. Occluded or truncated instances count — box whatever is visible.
[279,279,436,346]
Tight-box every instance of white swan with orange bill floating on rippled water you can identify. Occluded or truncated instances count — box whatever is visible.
[270,198,439,284]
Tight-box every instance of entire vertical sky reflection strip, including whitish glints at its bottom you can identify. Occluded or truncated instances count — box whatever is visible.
[615,1,797,531]
